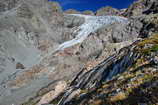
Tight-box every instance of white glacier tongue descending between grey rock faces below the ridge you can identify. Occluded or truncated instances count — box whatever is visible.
[56,14,128,51]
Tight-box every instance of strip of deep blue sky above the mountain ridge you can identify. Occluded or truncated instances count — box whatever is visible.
[49,0,136,11]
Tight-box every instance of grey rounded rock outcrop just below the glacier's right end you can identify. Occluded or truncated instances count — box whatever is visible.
[112,18,143,43]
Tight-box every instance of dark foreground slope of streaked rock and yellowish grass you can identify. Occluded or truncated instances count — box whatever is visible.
[54,35,158,105]
